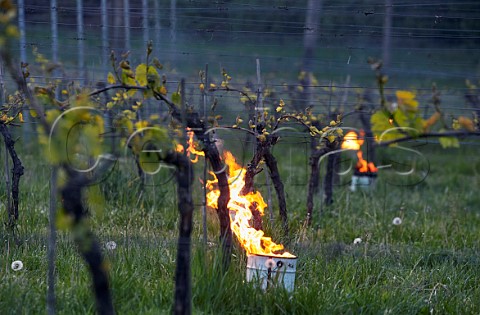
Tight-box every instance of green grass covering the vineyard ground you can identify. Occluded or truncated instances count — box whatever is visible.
[0,146,480,314]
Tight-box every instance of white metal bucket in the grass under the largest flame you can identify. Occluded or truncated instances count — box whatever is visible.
[247,255,297,292]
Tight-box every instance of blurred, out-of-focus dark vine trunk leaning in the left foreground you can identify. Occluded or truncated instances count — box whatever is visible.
[60,165,115,315]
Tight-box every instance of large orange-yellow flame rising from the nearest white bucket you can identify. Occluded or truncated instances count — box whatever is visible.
[207,150,296,257]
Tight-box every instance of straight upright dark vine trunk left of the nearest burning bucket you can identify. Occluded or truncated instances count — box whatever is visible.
[159,152,194,314]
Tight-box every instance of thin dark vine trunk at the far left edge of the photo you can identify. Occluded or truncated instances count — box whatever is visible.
[0,124,23,227]
